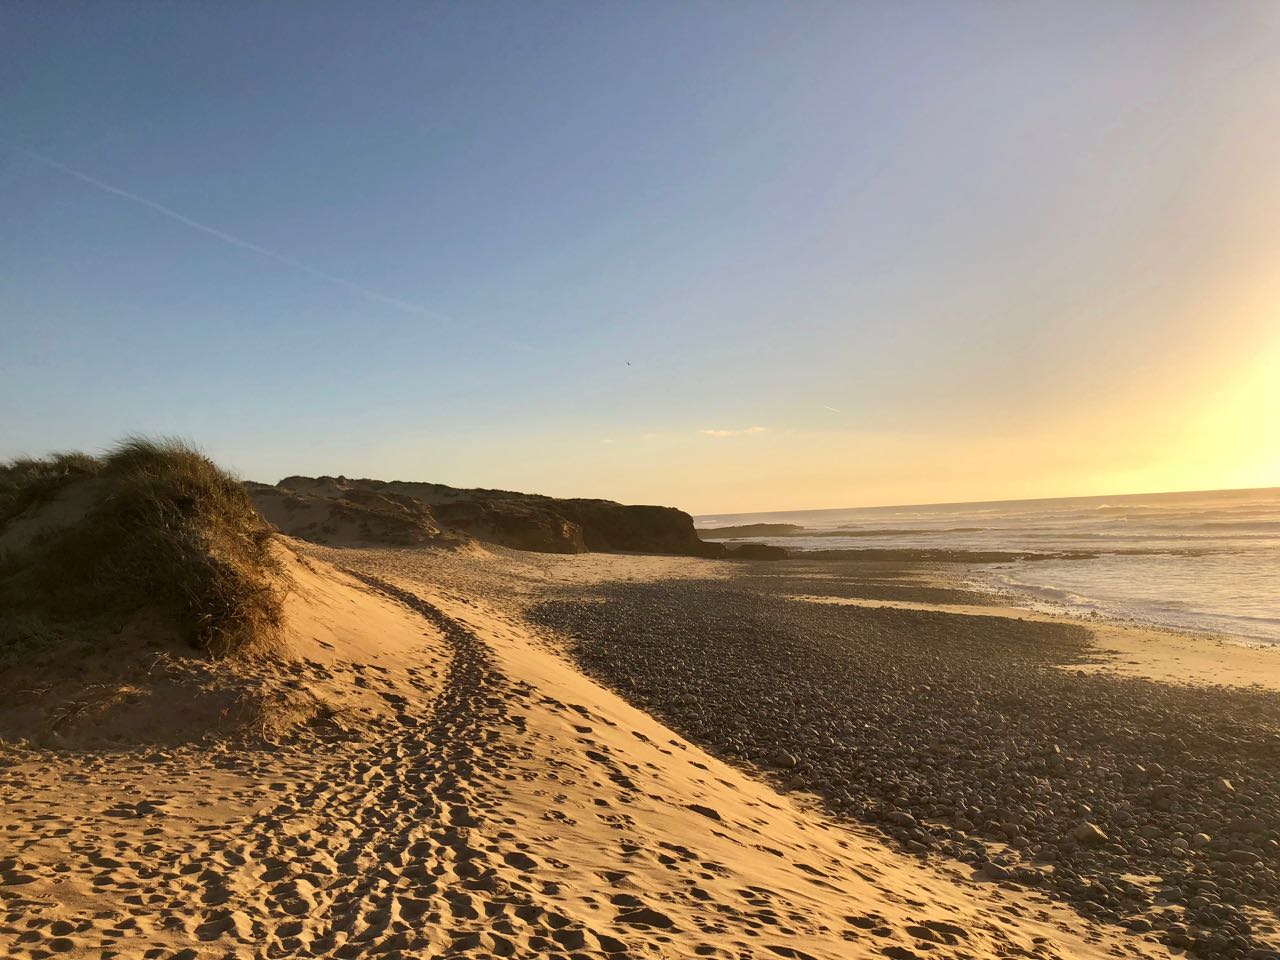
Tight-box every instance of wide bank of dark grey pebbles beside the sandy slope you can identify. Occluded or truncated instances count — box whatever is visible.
[532,571,1280,960]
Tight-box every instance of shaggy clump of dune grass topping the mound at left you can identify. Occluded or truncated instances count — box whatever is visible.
[0,436,284,655]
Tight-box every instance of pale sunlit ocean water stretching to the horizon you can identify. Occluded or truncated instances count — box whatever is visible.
[695,488,1280,644]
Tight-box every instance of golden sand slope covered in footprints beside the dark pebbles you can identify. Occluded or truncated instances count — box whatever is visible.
[0,545,1177,959]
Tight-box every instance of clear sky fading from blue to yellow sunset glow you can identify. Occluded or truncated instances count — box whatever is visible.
[0,0,1280,513]
